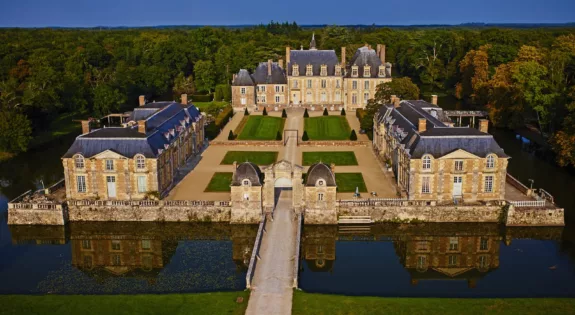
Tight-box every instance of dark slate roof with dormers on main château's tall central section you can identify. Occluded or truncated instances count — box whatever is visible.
[287,50,339,77]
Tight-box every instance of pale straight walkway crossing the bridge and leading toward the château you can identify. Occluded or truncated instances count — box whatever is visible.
[246,114,303,315]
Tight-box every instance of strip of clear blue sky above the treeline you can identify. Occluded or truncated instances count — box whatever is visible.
[0,0,575,27]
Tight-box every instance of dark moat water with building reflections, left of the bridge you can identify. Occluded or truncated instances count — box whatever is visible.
[0,222,257,294]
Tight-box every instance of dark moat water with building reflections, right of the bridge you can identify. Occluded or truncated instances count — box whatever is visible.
[300,223,575,296]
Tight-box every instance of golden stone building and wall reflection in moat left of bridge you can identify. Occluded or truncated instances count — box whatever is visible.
[10,222,257,284]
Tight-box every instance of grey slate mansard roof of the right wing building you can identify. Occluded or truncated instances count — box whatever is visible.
[377,100,508,159]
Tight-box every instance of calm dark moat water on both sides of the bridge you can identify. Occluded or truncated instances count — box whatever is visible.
[0,108,575,297]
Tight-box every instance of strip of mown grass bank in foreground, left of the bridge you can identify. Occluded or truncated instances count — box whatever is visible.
[0,291,249,315]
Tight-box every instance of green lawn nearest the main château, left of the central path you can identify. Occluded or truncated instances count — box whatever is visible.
[236,116,285,140]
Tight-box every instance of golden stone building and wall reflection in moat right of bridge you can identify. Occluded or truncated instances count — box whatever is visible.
[302,223,563,287]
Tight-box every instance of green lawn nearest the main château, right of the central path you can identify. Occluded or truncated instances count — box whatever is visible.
[304,116,351,140]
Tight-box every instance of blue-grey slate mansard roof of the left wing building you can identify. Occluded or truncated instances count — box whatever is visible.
[63,102,201,158]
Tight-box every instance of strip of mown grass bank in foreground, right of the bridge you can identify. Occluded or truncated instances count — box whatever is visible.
[292,291,575,315]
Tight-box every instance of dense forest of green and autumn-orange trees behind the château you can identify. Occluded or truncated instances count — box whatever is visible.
[0,23,575,166]
